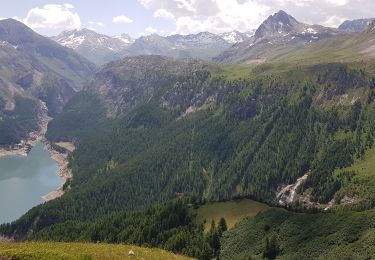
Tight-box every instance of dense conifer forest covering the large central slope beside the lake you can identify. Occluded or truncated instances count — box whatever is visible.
[0,60,375,257]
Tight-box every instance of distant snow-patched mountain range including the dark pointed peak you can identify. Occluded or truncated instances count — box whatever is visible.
[52,11,373,65]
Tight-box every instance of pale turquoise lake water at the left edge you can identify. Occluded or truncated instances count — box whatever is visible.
[0,144,60,224]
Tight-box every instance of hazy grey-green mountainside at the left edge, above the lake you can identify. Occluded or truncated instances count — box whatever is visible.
[0,19,95,145]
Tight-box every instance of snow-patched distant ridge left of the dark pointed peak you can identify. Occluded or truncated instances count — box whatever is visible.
[52,29,253,65]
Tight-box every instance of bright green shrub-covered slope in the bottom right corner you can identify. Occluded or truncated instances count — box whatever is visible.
[221,210,375,260]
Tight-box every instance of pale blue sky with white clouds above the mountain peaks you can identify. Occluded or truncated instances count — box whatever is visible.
[0,0,375,38]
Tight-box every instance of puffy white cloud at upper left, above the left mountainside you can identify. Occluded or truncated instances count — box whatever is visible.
[20,4,81,29]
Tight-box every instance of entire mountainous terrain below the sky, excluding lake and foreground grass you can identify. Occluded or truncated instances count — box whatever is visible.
[0,8,375,260]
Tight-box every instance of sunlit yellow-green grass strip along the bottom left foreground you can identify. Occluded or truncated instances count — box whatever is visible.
[0,242,192,260]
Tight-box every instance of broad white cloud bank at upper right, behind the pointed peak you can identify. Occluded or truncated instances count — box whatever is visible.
[138,0,375,34]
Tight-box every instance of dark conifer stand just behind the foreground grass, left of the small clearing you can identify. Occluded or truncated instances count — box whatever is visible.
[3,196,227,259]
